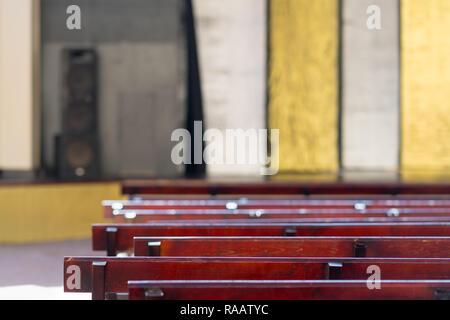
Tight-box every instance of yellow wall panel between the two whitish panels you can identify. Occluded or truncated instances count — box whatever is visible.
[269,0,338,172]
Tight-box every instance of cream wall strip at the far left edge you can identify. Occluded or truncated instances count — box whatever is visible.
[0,0,40,170]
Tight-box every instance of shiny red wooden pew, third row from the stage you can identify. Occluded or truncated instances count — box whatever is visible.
[113,208,450,223]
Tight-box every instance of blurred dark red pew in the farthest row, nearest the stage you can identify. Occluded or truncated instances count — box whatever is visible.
[122,179,450,196]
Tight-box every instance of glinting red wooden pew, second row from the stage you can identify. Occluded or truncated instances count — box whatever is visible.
[102,198,450,218]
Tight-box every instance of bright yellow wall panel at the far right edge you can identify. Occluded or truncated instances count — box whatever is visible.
[401,0,450,171]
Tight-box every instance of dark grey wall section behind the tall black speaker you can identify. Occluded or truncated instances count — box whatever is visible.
[41,0,186,177]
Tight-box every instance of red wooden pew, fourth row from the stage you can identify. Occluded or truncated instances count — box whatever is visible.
[92,221,450,256]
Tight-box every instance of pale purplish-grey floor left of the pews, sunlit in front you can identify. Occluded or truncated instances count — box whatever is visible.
[0,239,95,300]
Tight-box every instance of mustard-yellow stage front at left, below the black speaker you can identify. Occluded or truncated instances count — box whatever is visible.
[0,182,125,244]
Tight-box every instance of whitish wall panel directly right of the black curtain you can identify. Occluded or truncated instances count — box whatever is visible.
[194,0,267,176]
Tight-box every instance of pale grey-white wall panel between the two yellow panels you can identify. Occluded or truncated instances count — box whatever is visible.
[341,0,400,172]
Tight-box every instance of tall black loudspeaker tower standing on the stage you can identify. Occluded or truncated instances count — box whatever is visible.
[55,49,100,179]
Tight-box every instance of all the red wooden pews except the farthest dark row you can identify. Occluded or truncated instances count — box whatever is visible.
[64,197,450,299]
